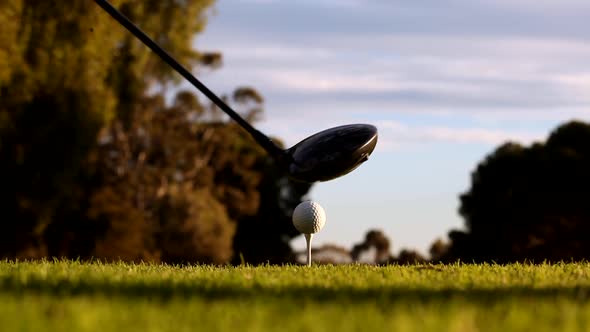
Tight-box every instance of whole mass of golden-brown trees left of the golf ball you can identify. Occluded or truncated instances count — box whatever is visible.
[0,0,310,263]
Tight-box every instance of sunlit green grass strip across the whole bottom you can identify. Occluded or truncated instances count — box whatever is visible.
[0,261,590,332]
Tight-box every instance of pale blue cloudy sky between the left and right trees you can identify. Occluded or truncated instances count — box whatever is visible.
[195,0,590,253]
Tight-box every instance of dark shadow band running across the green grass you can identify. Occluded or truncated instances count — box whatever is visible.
[0,277,590,303]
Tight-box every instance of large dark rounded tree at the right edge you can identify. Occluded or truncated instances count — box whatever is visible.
[447,121,590,262]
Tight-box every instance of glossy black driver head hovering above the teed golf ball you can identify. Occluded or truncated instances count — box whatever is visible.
[286,124,377,183]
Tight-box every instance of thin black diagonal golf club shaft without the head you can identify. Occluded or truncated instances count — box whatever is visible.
[94,0,283,157]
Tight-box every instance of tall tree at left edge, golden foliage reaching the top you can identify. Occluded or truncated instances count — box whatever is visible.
[0,0,211,256]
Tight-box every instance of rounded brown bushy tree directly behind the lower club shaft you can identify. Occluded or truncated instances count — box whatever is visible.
[83,91,309,263]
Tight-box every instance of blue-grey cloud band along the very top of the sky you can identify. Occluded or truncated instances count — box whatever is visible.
[202,0,590,42]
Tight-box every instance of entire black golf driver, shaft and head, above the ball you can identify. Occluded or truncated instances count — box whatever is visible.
[94,0,377,183]
